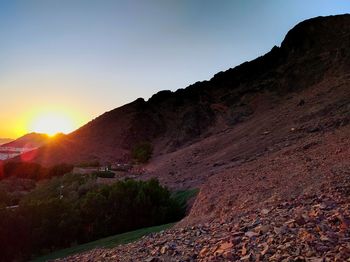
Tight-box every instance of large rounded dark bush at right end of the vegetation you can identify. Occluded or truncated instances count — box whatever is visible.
[80,179,183,241]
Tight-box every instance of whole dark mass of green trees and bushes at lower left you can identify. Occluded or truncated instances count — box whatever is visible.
[0,174,185,261]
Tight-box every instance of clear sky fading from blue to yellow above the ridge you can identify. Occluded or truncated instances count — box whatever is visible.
[0,0,350,138]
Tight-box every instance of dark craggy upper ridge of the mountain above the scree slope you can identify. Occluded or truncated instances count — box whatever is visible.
[26,15,350,168]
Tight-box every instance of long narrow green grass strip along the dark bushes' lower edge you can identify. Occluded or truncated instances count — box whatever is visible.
[32,223,175,262]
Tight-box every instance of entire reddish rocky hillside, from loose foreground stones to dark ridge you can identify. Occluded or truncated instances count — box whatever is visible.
[54,15,350,261]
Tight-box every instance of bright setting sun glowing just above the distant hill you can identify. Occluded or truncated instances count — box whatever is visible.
[29,112,75,136]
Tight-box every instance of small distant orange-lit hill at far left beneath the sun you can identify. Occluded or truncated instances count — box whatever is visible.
[1,133,50,148]
